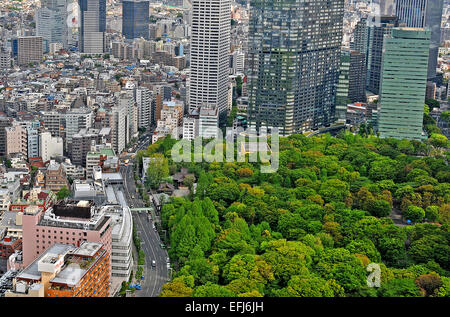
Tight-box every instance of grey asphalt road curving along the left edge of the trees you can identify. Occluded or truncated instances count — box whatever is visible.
[120,131,169,297]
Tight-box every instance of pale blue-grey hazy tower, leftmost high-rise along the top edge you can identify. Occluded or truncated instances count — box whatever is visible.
[36,0,69,47]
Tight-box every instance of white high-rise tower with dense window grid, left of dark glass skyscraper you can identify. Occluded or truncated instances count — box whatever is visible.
[189,0,231,121]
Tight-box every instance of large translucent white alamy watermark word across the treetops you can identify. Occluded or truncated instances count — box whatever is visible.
[171,128,279,173]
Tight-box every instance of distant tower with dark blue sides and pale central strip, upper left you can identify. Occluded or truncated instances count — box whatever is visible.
[78,0,106,54]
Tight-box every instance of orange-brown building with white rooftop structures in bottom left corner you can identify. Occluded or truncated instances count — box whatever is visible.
[5,242,111,297]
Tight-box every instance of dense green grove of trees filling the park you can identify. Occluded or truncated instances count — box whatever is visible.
[138,132,450,297]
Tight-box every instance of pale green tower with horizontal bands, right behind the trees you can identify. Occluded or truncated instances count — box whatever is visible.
[378,28,431,140]
